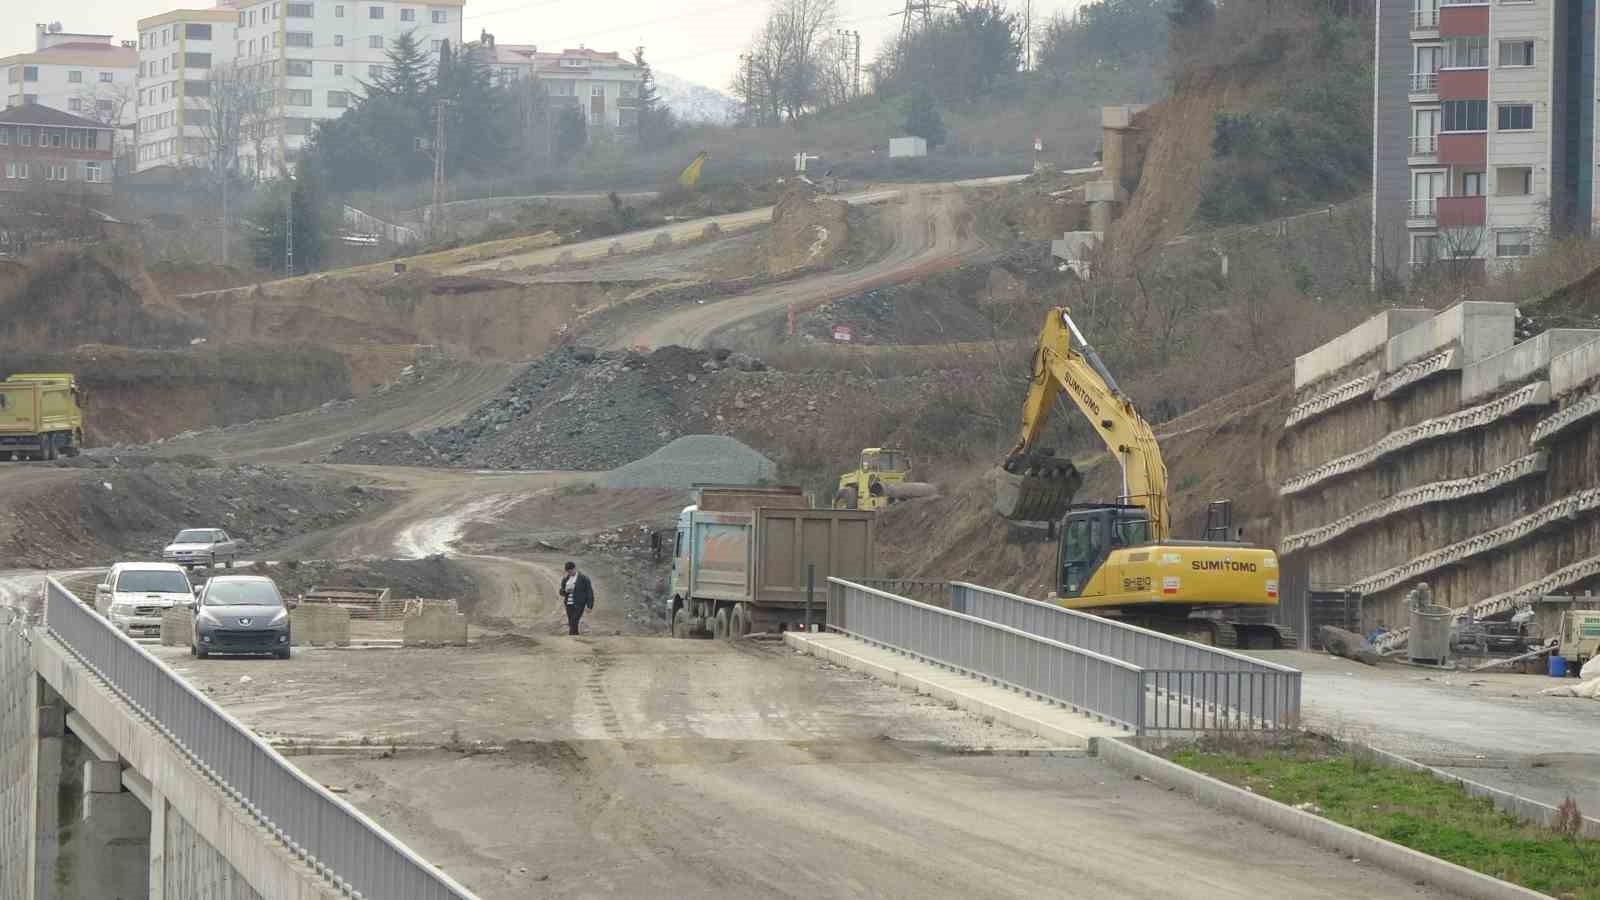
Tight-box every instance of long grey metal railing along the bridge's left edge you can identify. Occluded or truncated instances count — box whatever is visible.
[45,578,474,900]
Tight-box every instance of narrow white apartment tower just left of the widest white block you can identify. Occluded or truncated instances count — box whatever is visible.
[134,8,238,171]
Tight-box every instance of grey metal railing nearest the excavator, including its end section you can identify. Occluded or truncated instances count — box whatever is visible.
[949,581,1301,730]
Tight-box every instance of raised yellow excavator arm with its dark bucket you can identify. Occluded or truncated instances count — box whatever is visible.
[995,306,1170,541]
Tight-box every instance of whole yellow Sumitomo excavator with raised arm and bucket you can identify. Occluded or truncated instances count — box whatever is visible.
[995,307,1296,649]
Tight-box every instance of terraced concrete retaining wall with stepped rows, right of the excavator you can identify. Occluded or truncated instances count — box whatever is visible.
[1277,303,1600,626]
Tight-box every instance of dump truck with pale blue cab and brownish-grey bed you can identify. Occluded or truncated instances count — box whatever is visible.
[672,485,877,639]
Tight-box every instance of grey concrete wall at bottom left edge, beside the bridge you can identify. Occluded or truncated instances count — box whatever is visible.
[0,607,37,898]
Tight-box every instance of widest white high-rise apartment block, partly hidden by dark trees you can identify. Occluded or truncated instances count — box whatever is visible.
[232,0,466,176]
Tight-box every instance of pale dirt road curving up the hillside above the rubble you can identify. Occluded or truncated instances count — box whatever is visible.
[610,191,989,349]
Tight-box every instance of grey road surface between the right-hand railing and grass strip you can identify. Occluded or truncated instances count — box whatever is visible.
[1251,650,1600,815]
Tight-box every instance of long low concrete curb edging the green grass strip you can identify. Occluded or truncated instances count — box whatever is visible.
[1094,740,1549,900]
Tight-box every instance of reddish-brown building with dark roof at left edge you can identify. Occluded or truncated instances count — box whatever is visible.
[0,102,115,197]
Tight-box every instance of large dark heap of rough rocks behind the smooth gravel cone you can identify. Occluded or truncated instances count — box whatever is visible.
[422,348,765,471]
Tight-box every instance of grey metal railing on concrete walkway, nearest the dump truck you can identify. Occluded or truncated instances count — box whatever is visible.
[827,578,1147,735]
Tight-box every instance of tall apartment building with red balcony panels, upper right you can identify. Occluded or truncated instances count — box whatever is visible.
[1373,0,1568,282]
